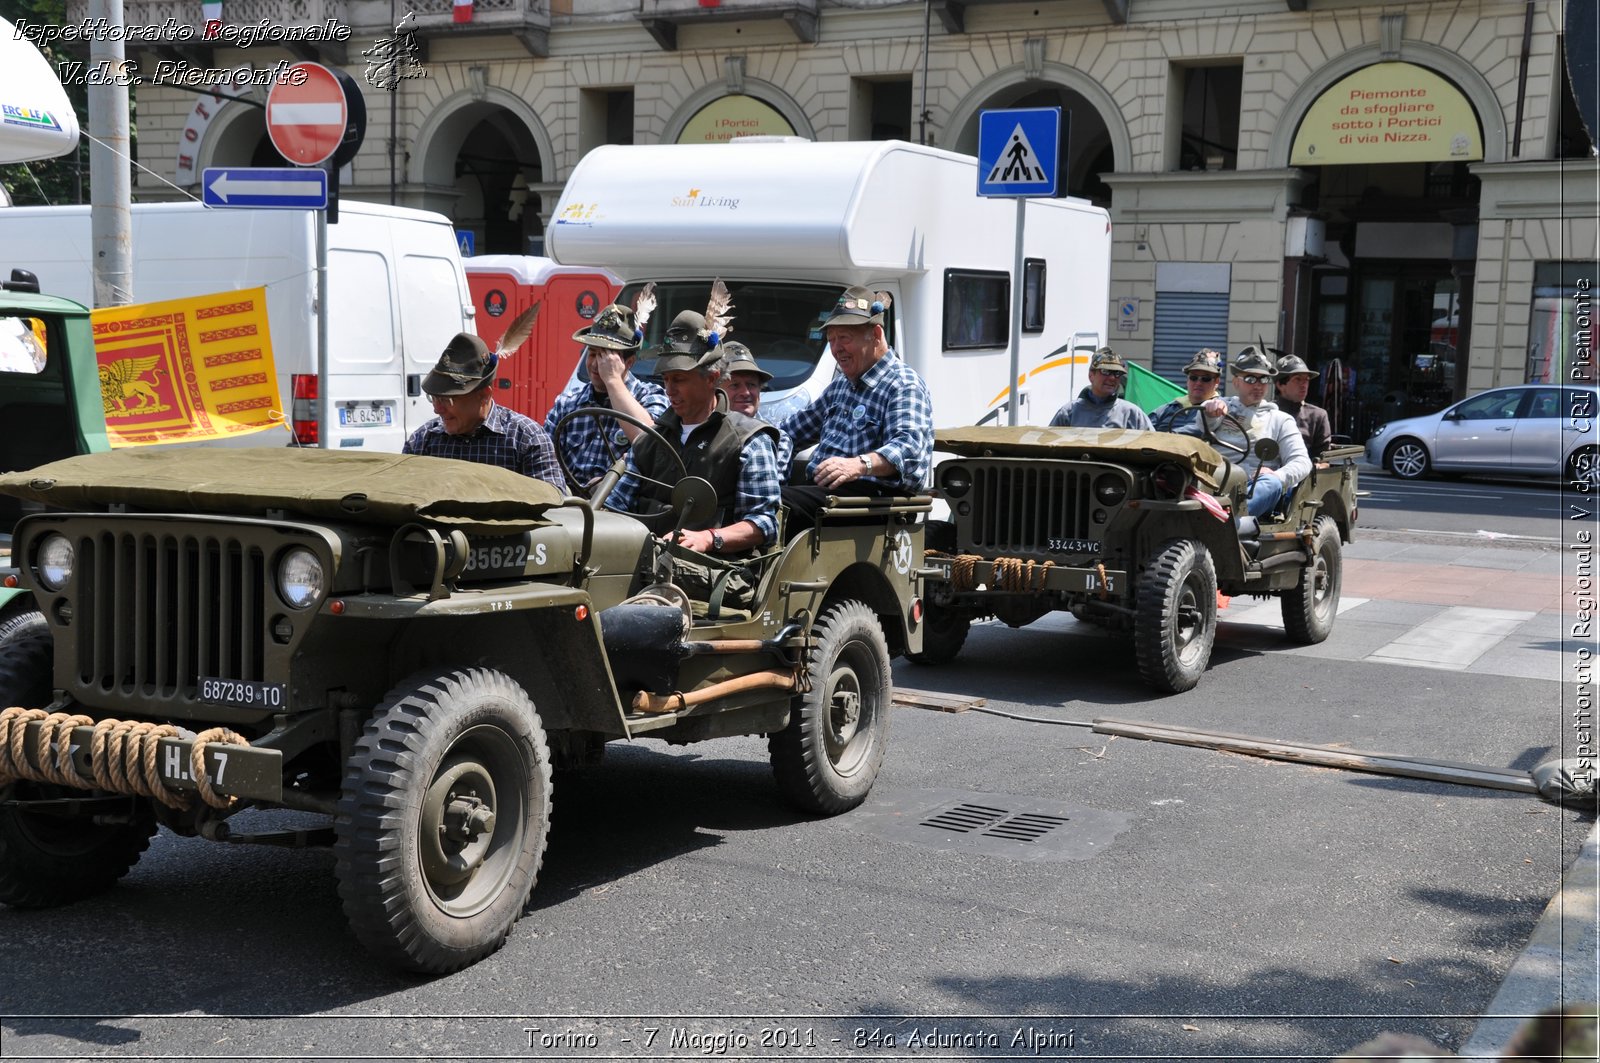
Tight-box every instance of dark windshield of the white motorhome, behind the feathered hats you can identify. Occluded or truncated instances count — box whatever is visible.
[604,277,844,392]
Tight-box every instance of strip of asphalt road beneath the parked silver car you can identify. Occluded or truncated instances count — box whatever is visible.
[1360,464,1595,543]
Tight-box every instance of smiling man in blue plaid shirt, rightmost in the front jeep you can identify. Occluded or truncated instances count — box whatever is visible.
[781,288,933,532]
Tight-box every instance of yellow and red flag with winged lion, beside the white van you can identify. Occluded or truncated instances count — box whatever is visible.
[90,288,286,447]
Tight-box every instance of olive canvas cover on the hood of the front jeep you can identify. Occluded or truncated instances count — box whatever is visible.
[0,447,562,533]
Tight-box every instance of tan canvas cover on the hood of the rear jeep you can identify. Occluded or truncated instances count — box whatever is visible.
[933,424,1222,491]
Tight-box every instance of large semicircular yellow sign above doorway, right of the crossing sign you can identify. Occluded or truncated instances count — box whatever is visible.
[1290,62,1483,166]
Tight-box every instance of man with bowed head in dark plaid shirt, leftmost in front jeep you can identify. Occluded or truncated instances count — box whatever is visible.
[402,333,566,495]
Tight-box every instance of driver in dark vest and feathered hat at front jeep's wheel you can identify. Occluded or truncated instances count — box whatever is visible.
[606,311,782,556]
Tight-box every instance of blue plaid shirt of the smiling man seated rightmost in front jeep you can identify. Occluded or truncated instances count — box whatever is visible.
[782,347,933,491]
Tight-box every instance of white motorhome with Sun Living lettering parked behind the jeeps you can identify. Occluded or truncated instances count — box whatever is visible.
[547,138,1110,426]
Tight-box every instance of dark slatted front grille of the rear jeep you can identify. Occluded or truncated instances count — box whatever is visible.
[971,464,1104,554]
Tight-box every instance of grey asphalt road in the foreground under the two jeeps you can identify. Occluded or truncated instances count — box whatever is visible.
[0,560,1590,1060]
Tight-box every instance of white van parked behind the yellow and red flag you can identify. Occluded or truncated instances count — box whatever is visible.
[0,200,472,451]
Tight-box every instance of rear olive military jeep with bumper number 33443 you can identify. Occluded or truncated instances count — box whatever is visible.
[907,423,1360,693]
